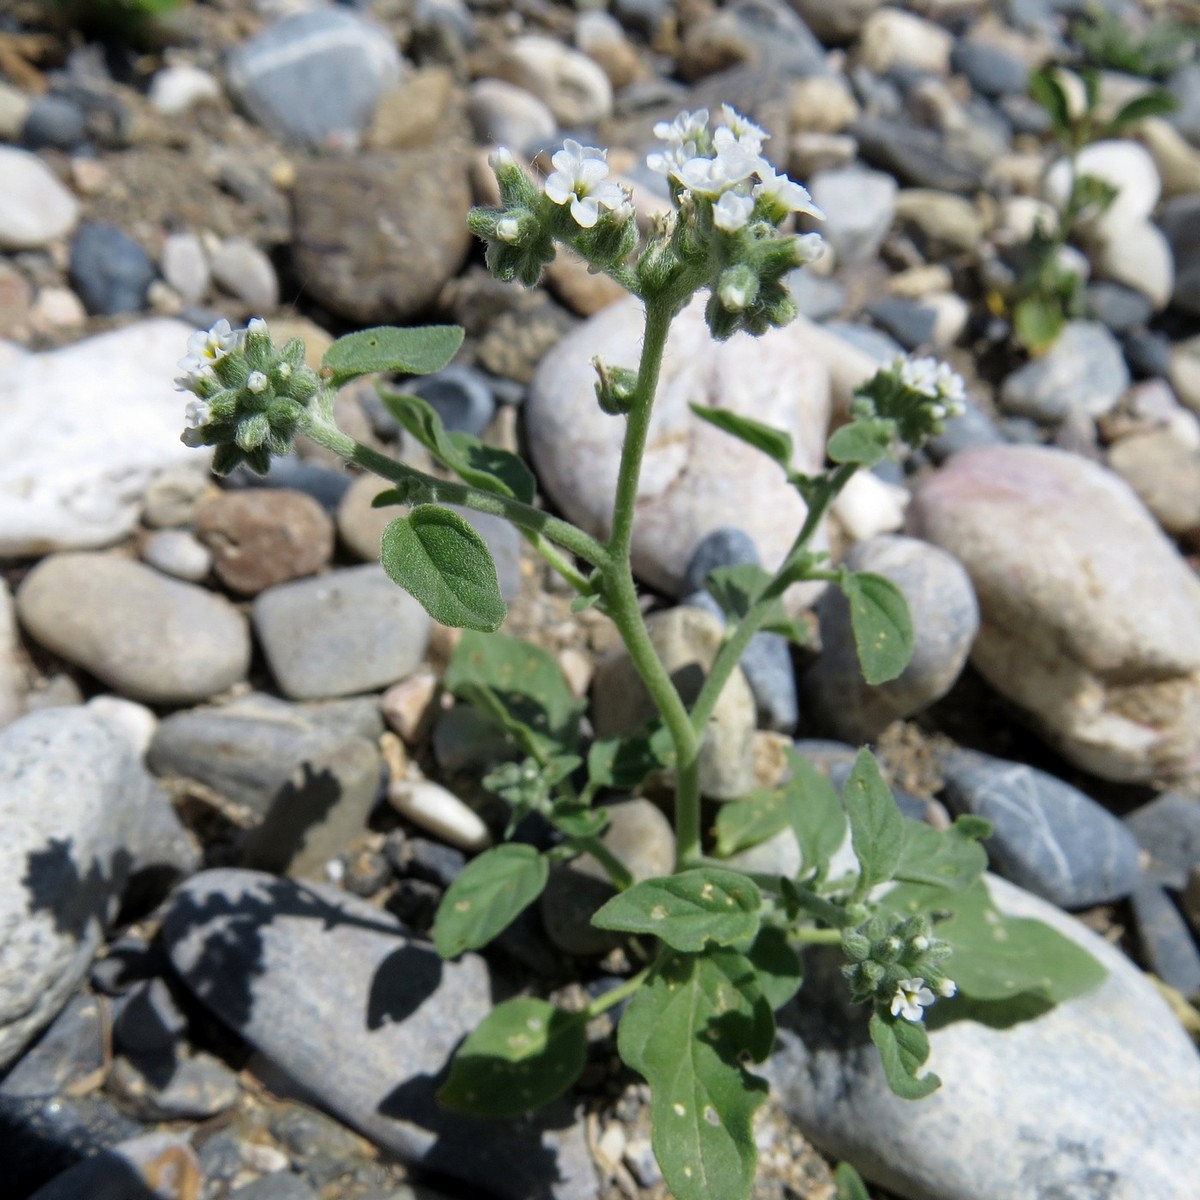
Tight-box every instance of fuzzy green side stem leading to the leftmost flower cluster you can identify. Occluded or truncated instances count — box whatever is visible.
[304,409,608,566]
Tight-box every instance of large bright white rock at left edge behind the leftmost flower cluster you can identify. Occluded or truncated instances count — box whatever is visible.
[0,324,203,556]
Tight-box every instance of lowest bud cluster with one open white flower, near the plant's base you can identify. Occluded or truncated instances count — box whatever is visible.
[841,916,958,1021]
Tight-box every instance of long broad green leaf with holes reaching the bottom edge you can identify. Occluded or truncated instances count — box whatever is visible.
[617,949,775,1200]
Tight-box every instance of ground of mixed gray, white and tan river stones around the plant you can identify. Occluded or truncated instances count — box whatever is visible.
[0,0,1200,1200]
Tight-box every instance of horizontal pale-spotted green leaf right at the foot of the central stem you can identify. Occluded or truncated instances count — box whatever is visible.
[592,866,762,953]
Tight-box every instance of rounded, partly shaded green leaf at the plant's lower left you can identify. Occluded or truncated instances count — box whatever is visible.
[438,996,588,1117]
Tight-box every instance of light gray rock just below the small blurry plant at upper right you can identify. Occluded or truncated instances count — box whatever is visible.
[1000,320,1130,424]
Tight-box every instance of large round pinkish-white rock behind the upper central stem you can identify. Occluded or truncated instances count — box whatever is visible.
[527,296,829,595]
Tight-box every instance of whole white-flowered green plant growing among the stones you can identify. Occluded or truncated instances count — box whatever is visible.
[180,107,1102,1200]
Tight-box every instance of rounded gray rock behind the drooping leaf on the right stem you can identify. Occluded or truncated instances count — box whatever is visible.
[800,538,979,742]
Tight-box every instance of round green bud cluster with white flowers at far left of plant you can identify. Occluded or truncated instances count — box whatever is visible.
[175,318,319,475]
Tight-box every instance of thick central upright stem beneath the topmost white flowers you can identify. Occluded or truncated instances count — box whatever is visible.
[601,301,700,866]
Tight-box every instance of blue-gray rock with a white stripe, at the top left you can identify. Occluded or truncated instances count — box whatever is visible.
[228,8,401,150]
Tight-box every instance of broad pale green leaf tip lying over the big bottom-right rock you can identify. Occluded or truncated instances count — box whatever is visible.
[936,880,1108,1004]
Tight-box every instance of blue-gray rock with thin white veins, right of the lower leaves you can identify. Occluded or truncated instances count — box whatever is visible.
[942,750,1141,908]
